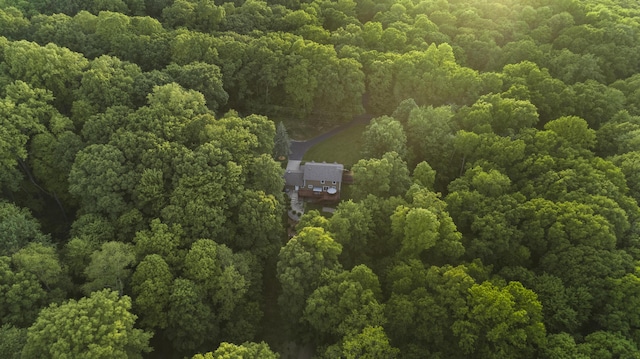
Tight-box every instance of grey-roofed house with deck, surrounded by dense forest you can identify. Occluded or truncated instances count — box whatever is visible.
[284,162,344,202]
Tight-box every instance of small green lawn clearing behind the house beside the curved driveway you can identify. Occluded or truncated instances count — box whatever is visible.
[304,124,366,168]
